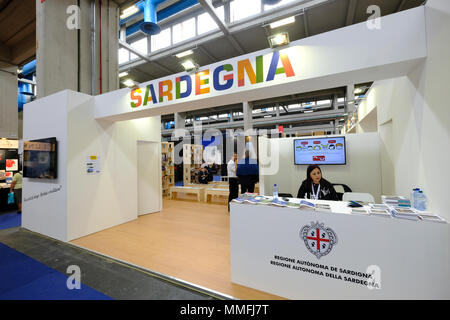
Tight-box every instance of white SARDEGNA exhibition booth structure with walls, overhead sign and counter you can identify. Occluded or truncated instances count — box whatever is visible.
[22,1,450,299]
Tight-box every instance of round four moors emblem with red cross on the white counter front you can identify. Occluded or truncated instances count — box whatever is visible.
[300,222,337,259]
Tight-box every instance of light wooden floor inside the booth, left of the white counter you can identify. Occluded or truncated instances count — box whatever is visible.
[72,196,282,300]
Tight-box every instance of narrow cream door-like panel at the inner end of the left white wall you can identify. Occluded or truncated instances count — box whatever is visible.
[137,141,162,216]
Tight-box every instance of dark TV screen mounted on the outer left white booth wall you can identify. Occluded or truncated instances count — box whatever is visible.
[23,138,58,179]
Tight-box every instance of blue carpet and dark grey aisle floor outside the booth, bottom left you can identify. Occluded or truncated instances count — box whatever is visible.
[0,228,229,300]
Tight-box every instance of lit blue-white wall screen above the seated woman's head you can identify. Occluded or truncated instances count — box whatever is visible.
[294,137,346,165]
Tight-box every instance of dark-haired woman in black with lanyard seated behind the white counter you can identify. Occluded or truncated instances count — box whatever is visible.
[297,164,339,201]
